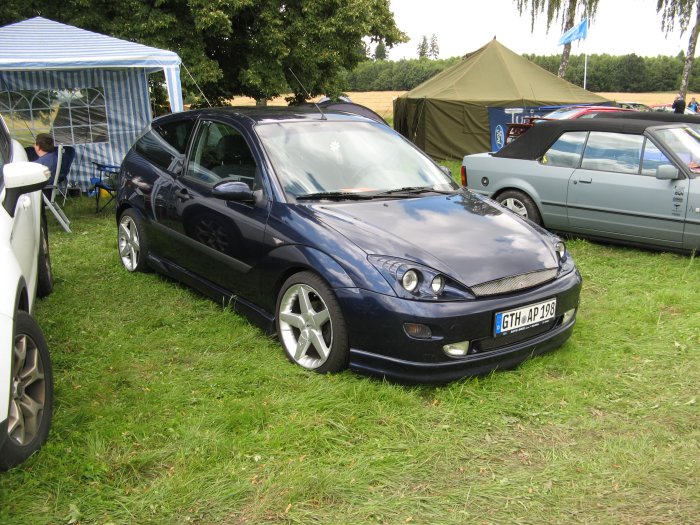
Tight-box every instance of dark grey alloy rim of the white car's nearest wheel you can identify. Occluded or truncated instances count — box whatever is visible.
[7,334,46,446]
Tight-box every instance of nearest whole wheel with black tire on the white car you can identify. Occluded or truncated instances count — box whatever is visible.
[0,311,53,470]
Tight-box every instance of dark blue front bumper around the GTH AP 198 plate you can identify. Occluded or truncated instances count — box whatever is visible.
[336,270,581,383]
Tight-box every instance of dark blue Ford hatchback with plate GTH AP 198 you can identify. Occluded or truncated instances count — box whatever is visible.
[117,107,581,382]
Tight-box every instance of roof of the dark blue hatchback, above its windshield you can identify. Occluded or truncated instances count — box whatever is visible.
[153,104,370,125]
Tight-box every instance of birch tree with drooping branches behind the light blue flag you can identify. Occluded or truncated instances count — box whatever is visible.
[513,0,600,77]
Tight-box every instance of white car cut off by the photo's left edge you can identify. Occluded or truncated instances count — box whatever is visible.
[0,114,53,470]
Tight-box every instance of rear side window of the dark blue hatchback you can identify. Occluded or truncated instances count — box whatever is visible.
[134,120,192,174]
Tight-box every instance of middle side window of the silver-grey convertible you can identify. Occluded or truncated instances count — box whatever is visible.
[581,131,644,173]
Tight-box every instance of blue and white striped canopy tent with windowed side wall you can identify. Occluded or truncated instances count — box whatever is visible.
[0,17,183,190]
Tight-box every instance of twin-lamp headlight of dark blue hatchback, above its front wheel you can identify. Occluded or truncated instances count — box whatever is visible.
[368,255,474,301]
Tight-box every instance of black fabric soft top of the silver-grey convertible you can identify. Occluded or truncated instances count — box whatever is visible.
[493,117,682,160]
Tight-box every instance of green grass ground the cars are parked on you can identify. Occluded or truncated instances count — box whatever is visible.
[0,197,700,525]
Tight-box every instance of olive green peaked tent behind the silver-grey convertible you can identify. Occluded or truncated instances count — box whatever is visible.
[394,38,611,159]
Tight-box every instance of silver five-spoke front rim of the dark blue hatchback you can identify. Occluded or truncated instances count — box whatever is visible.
[279,284,333,370]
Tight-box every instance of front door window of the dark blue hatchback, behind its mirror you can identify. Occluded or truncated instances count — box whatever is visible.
[186,122,258,189]
